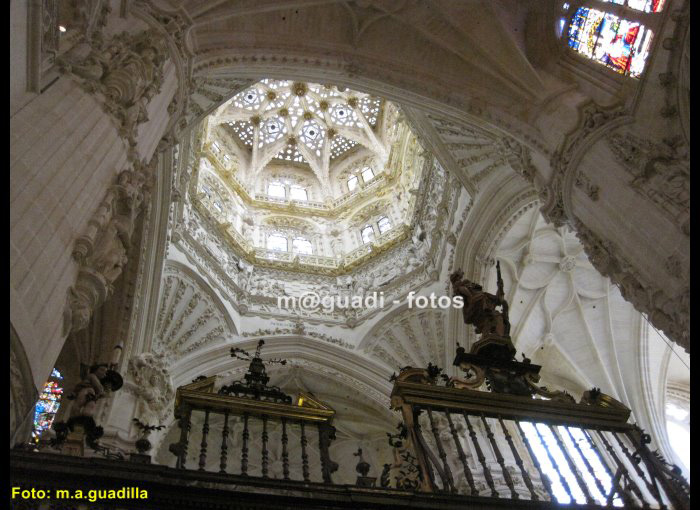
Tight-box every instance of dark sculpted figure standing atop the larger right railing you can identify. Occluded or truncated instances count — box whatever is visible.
[450,268,510,337]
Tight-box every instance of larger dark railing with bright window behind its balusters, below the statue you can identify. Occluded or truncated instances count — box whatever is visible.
[392,346,690,509]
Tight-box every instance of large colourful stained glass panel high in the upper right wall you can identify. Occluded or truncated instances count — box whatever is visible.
[568,7,653,77]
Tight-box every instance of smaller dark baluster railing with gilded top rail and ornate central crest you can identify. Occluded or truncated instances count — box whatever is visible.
[170,341,338,484]
